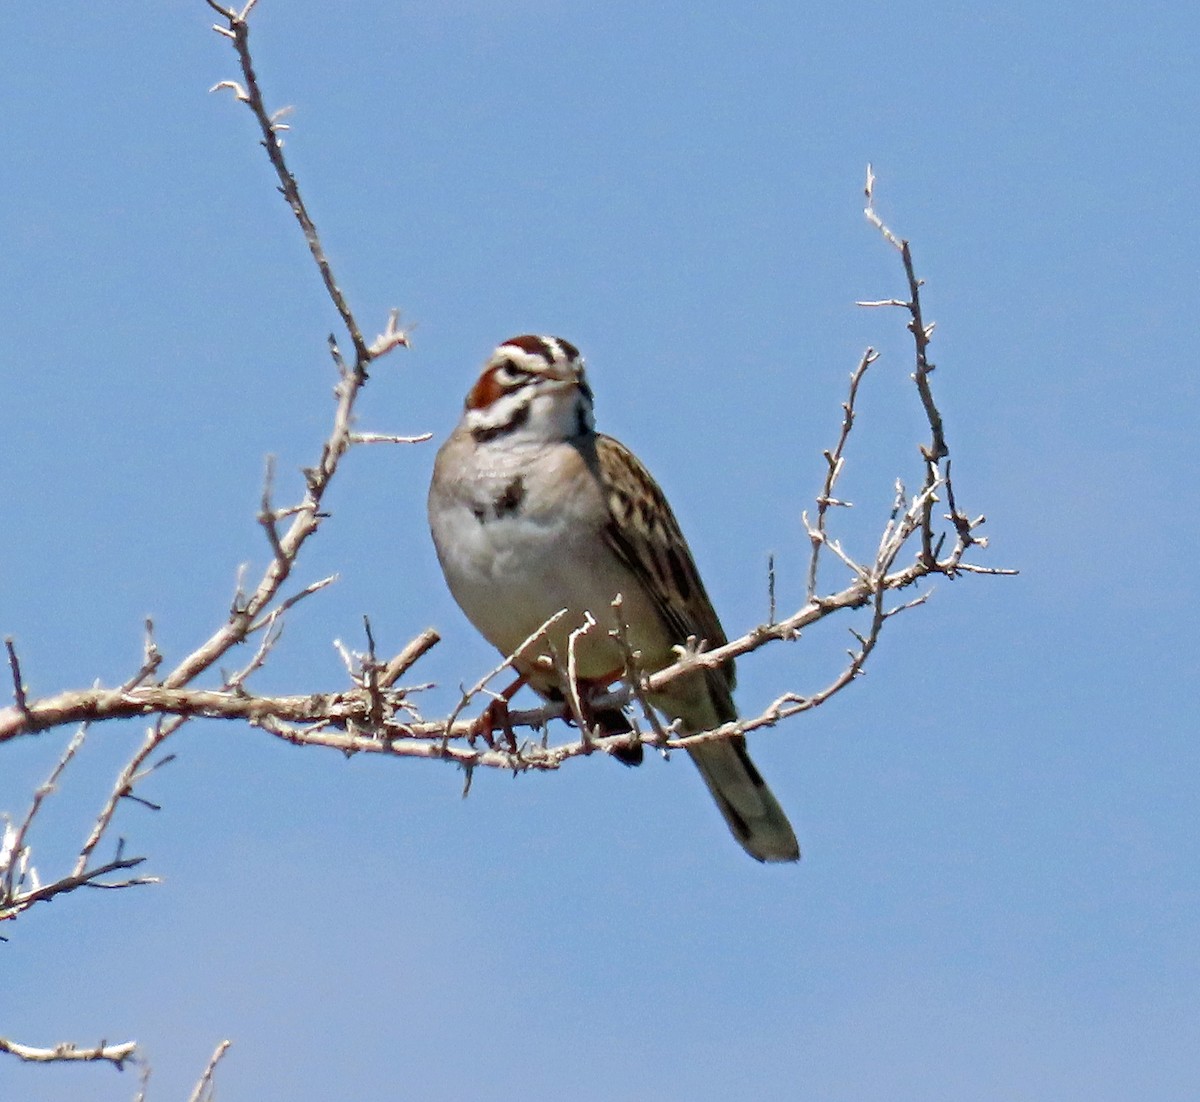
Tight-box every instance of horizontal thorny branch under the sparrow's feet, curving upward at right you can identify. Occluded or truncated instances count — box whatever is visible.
[0,153,1014,792]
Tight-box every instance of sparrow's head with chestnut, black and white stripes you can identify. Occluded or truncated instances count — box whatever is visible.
[463,334,594,443]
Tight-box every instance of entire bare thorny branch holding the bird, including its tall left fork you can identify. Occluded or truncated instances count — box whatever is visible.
[0,0,1014,993]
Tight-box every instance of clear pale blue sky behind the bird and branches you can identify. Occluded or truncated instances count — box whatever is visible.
[0,0,1200,1102]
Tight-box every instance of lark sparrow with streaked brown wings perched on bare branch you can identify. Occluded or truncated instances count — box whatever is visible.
[428,335,800,861]
